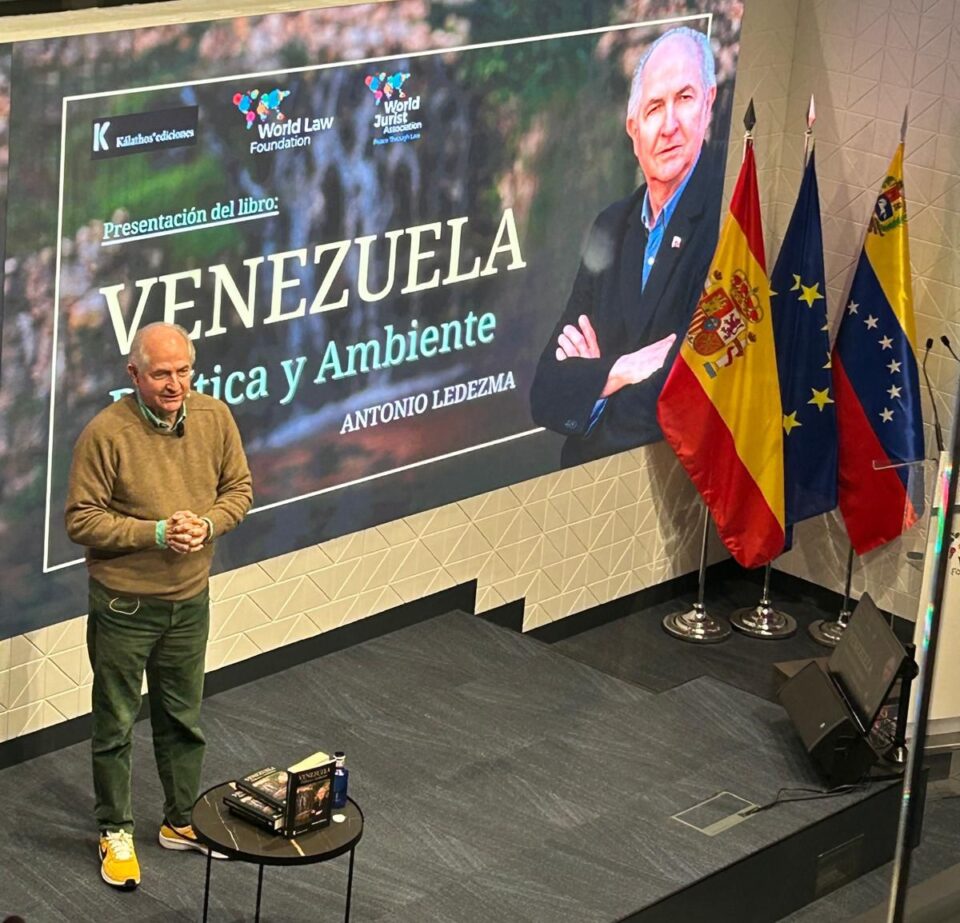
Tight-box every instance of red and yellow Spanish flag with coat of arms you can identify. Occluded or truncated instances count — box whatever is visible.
[657,138,784,567]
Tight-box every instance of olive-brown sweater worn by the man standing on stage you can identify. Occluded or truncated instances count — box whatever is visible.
[66,391,253,600]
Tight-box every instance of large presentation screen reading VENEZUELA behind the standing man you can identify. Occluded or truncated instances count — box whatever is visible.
[0,0,741,636]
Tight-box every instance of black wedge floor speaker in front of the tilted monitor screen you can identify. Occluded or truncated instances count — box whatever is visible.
[779,662,877,786]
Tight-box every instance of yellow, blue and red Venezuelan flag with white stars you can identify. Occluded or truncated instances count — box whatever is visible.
[833,143,924,554]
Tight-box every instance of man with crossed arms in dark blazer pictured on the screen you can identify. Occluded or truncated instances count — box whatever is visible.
[530,27,723,466]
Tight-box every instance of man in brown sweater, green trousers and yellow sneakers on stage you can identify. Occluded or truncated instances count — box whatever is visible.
[66,323,253,890]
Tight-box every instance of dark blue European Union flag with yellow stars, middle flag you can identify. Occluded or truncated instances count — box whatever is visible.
[770,152,837,546]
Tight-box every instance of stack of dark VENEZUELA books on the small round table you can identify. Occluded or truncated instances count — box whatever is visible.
[223,751,335,837]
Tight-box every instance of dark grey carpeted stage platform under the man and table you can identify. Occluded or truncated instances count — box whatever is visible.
[0,612,924,923]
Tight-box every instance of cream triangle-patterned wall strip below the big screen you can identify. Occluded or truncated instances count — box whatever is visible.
[0,445,702,740]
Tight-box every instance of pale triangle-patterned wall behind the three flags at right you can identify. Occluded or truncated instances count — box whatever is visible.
[764,0,960,619]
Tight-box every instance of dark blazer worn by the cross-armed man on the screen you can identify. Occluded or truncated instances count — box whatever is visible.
[530,148,723,467]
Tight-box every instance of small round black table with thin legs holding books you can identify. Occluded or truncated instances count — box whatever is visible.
[191,782,363,923]
